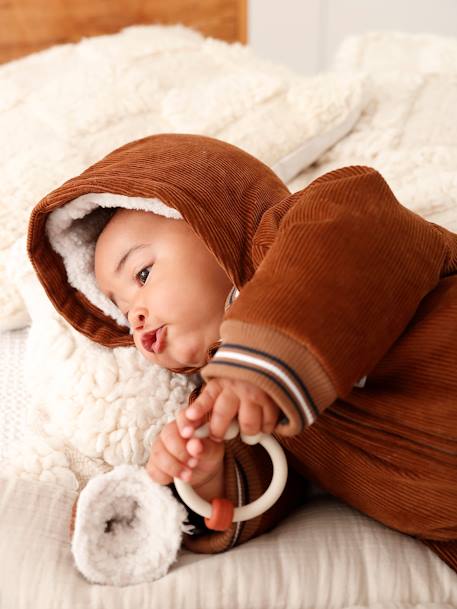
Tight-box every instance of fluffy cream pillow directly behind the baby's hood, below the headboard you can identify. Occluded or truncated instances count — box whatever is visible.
[0,25,364,330]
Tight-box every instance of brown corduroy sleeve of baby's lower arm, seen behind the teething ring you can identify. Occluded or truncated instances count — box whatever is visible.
[183,437,311,554]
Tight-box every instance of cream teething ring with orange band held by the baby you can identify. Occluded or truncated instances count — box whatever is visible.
[174,422,287,531]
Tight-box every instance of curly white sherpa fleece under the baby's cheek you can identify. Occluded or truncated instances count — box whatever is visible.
[0,236,196,491]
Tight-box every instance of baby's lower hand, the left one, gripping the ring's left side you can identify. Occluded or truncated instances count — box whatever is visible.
[146,410,224,487]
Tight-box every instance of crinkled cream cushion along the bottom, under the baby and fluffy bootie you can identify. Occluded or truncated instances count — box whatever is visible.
[0,479,457,609]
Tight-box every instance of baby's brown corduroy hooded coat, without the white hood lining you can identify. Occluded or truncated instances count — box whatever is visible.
[28,135,457,568]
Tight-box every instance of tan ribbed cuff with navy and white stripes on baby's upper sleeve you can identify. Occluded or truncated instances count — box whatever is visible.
[200,320,337,435]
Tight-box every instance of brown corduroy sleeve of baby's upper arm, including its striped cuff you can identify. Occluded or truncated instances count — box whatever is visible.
[201,166,446,435]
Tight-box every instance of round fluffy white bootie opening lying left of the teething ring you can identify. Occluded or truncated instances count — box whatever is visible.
[71,465,192,586]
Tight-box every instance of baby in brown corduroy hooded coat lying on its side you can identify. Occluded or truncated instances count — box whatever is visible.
[28,134,457,569]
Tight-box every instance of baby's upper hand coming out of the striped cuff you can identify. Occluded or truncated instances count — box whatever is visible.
[181,378,281,445]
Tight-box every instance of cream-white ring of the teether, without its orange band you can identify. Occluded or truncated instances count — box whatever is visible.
[174,421,287,522]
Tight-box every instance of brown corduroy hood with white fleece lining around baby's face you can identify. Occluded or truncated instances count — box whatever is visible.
[28,134,290,347]
